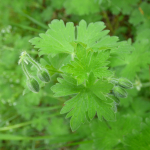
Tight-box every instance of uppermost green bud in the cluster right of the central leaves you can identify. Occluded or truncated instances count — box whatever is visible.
[118,78,133,89]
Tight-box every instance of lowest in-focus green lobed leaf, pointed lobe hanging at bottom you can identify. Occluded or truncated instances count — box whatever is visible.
[52,73,115,131]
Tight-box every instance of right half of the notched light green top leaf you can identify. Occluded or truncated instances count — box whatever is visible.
[77,20,133,56]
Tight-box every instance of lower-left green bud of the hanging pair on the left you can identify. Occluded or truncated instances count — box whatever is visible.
[27,77,40,93]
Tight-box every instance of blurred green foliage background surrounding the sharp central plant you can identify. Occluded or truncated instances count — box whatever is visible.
[0,0,150,150]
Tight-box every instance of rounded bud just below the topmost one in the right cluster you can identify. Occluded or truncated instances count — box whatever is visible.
[113,86,128,98]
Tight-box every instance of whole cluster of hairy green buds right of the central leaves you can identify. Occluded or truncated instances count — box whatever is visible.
[111,78,133,103]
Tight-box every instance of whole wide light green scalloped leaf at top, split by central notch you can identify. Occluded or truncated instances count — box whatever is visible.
[30,19,132,56]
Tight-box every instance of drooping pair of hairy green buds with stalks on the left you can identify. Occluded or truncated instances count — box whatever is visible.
[19,52,50,93]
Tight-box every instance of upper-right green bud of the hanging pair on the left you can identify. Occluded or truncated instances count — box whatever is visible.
[37,68,50,82]
